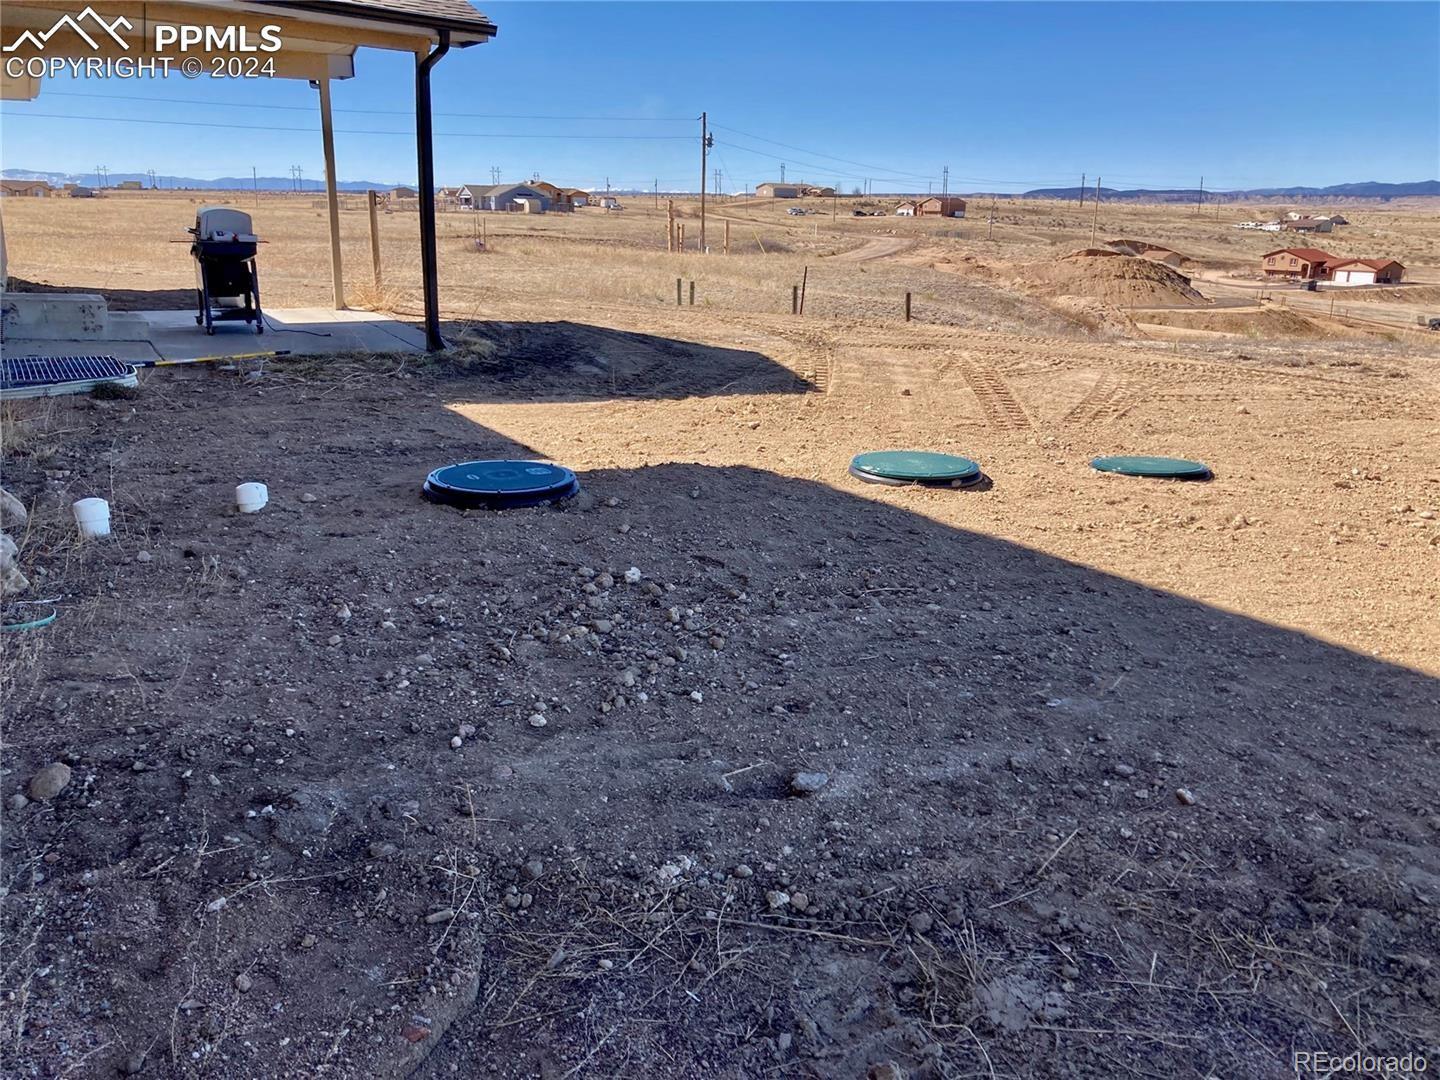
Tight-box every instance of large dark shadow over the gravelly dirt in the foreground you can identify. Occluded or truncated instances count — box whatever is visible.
[0,365,1440,1077]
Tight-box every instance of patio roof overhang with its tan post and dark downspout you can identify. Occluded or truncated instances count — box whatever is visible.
[0,0,497,348]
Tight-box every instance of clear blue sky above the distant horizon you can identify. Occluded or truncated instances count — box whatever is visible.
[0,3,1440,192]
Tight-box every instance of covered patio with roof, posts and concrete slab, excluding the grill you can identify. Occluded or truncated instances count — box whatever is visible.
[0,0,497,359]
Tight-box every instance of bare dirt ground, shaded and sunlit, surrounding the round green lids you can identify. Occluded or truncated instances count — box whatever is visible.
[0,190,1440,1077]
